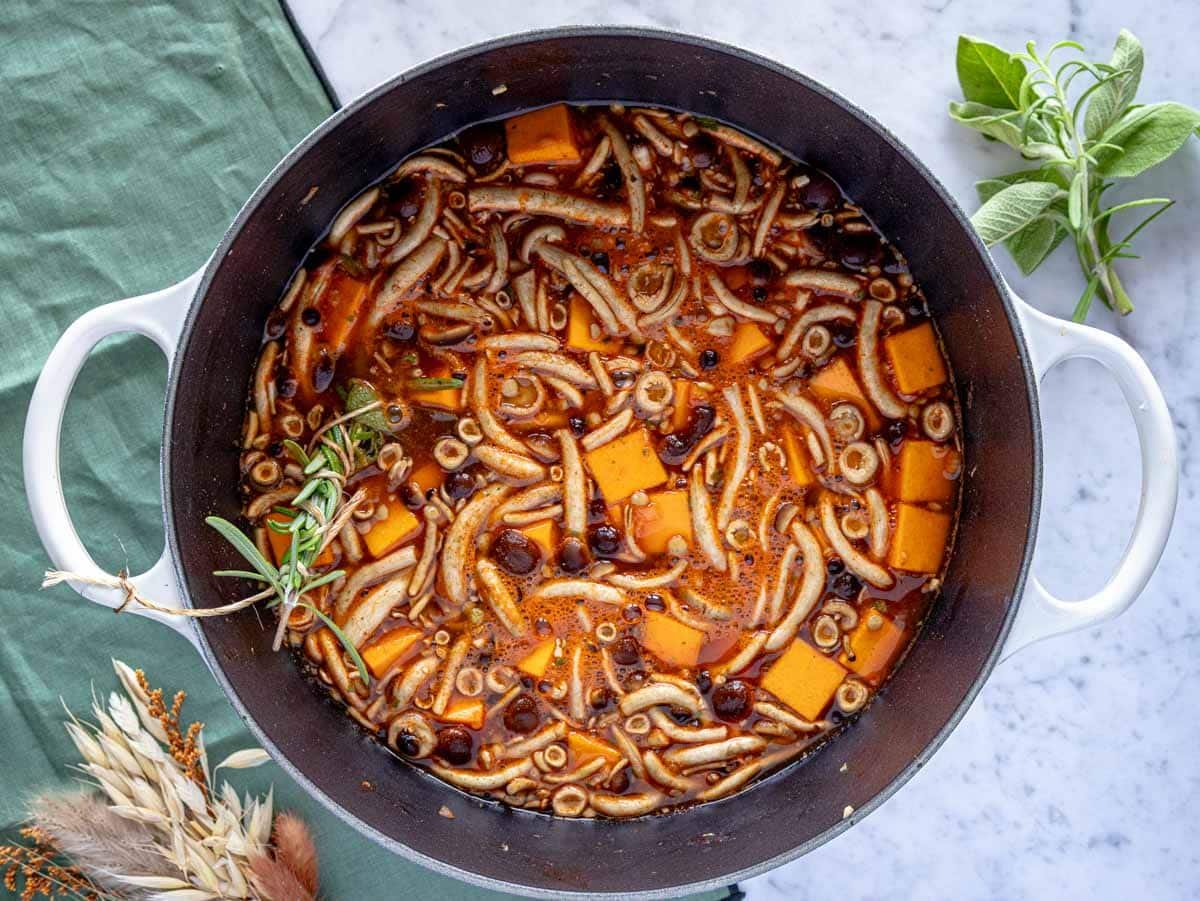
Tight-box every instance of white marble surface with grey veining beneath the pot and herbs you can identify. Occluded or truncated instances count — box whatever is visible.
[293,0,1200,901]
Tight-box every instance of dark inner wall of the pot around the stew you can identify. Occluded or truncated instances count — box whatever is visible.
[166,31,1038,894]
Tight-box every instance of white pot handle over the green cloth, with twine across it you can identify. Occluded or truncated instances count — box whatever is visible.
[23,268,204,648]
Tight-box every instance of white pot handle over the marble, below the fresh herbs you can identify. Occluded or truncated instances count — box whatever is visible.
[1002,294,1180,657]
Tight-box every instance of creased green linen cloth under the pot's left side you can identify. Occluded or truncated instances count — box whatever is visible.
[0,0,725,900]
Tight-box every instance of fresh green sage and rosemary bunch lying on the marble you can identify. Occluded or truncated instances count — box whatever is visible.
[950,30,1200,322]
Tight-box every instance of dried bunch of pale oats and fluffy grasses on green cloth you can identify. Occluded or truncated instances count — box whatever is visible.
[0,660,317,901]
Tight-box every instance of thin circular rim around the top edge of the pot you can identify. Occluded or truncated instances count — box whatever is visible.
[160,25,1043,901]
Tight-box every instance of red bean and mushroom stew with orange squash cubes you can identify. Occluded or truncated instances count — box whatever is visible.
[241,106,962,817]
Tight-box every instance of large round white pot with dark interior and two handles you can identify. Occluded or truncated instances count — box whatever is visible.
[24,29,1177,897]
